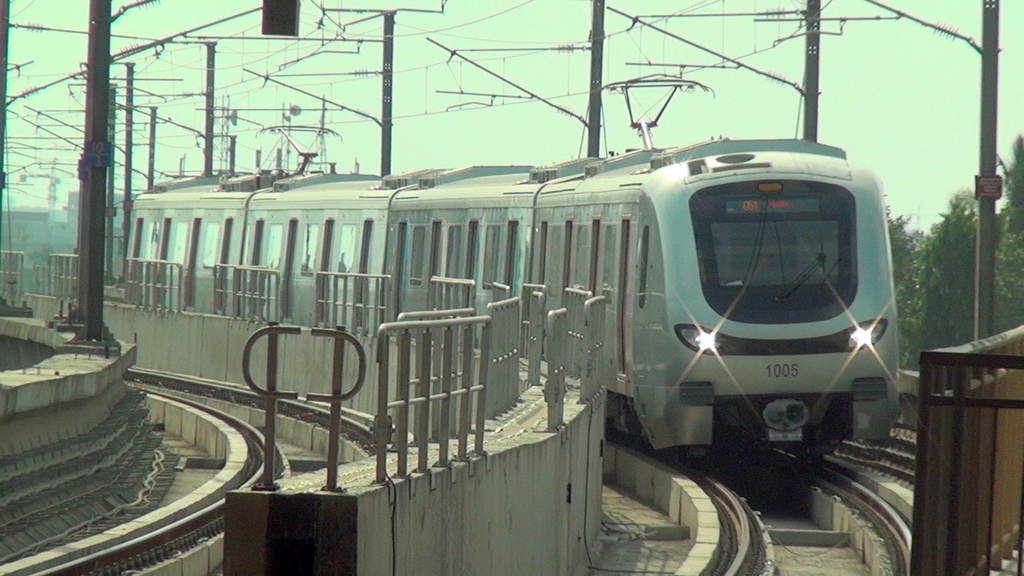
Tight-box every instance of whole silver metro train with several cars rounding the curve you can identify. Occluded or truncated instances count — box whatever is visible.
[129,139,898,453]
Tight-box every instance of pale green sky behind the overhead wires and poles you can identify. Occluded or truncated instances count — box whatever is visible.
[7,0,1024,228]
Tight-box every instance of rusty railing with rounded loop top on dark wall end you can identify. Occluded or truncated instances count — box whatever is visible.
[242,324,367,492]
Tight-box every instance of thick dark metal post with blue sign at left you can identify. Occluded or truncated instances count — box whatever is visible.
[78,0,111,341]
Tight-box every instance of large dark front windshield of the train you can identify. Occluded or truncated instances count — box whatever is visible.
[690,180,857,324]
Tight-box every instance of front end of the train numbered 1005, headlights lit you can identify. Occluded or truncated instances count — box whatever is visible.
[633,140,898,453]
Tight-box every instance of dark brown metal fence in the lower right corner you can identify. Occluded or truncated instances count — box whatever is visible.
[911,327,1024,576]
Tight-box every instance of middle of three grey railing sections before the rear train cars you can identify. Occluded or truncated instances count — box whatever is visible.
[213,264,281,322]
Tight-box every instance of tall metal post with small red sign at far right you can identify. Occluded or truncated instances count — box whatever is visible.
[974,0,1001,339]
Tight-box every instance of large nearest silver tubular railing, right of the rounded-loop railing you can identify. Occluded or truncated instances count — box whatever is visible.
[374,316,493,484]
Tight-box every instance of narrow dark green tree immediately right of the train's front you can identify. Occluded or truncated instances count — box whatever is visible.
[886,210,926,368]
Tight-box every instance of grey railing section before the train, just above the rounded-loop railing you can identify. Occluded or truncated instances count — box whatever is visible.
[313,272,391,335]
